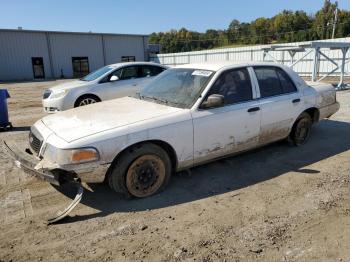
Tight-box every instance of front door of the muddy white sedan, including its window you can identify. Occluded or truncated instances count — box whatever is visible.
[192,67,261,164]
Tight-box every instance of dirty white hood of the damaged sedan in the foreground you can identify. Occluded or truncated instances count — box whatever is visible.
[41,97,183,143]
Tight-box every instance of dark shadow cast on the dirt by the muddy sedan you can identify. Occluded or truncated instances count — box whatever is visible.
[54,120,350,223]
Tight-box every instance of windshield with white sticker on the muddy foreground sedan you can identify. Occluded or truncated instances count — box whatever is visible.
[140,68,214,108]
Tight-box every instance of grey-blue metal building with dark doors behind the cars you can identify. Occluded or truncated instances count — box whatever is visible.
[0,29,148,81]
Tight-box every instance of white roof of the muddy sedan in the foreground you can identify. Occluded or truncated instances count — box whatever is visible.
[173,61,283,71]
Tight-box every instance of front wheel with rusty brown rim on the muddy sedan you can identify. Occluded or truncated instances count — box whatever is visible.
[108,143,172,198]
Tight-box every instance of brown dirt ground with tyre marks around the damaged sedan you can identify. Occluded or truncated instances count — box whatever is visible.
[0,81,350,261]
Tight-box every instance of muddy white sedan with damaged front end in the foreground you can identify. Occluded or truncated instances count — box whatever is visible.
[7,63,339,222]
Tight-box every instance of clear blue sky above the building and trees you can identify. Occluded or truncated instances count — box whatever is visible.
[0,0,350,34]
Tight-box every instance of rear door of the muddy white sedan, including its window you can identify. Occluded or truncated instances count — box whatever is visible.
[254,66,302,144]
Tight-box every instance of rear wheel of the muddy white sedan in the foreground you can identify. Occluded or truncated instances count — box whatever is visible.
[289,112,312,146]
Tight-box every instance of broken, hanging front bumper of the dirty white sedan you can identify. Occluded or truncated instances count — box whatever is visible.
[4,142,84,224]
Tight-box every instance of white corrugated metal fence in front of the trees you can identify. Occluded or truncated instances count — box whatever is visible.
[150,37,350,76]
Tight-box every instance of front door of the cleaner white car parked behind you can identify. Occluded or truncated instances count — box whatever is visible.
[99,66,140,100]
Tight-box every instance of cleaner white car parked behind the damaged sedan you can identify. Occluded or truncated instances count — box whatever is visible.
[43,62,167,113]
